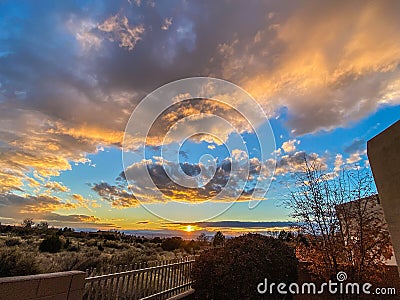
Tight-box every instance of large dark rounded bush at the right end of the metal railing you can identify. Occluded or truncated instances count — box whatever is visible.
[192,234,297,299]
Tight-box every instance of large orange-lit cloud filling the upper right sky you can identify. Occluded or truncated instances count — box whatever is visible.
[209,0,400,135]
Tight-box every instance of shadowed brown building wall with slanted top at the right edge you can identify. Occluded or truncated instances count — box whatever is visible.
[368,121,400,276]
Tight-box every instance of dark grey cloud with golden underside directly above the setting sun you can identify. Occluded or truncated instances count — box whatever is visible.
[117,149,272,203]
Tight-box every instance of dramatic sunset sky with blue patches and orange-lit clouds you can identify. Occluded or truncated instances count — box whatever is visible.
[0,0,400,236]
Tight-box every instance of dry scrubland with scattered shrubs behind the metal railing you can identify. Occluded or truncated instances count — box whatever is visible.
[0,222,209,277]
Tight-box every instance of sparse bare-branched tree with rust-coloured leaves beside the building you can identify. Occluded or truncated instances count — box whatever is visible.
[285,157,392,282]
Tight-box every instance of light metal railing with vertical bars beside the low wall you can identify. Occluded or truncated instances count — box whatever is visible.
[84,256,194,300]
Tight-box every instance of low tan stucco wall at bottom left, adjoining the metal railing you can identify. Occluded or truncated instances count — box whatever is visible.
[0,271,86,300]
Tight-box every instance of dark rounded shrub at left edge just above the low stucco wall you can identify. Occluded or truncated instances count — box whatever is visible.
[0,249,40,277]
